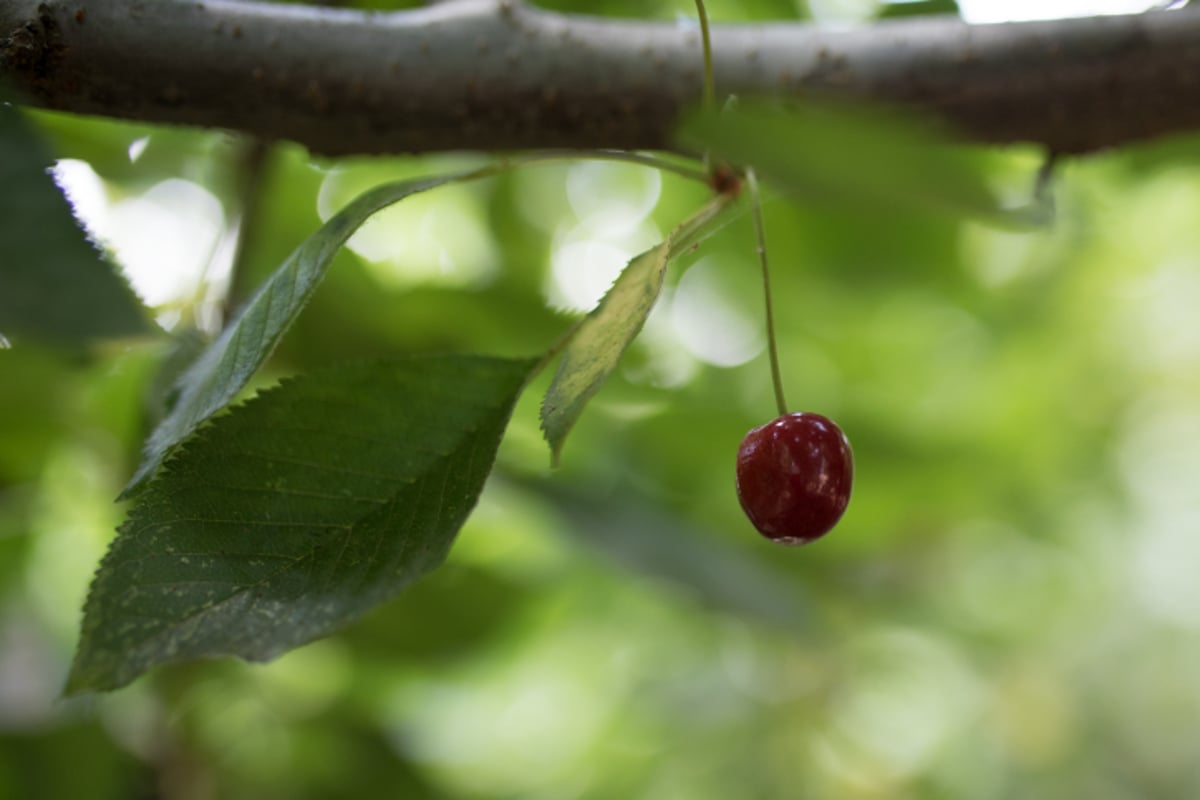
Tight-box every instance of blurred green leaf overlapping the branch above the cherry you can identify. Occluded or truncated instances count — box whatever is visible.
[679,101,1014,222]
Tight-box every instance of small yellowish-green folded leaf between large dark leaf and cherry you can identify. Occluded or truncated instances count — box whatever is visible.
[541,194,731,464]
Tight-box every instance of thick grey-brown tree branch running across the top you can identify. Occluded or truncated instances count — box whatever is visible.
[0,0,1200,155]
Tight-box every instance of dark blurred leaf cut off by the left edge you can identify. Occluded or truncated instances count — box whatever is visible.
[0,97,151,344]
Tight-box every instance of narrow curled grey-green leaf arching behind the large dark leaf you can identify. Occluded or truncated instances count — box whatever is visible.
[122,167,494,497]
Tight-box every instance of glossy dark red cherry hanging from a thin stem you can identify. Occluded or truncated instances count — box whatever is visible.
[737,413,854,545]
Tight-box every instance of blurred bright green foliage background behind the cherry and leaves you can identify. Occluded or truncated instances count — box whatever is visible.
[0,2,1200,800]
